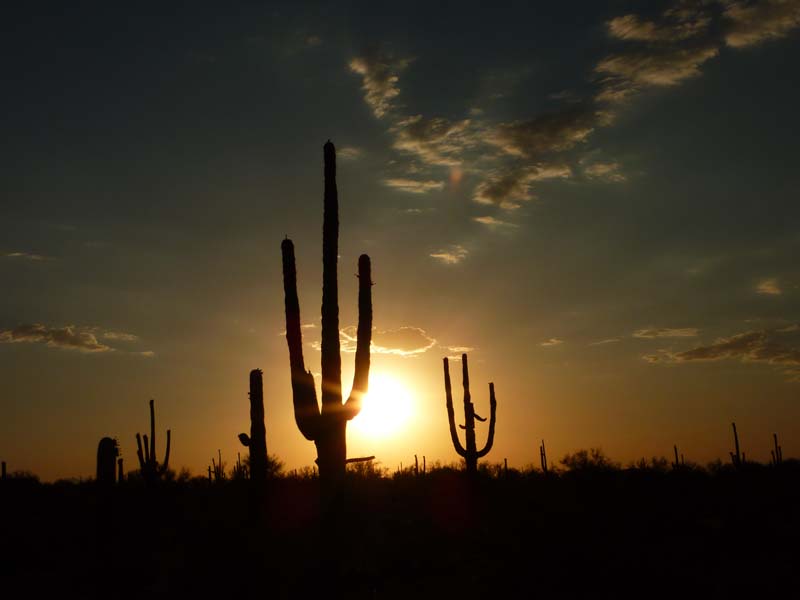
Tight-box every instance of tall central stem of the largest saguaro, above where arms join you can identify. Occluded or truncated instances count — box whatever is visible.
[321,140,342,415]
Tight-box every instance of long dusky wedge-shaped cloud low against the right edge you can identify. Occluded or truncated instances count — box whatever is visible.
[643,328,800,367]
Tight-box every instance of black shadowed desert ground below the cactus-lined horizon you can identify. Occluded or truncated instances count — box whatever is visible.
[0,462,800,599]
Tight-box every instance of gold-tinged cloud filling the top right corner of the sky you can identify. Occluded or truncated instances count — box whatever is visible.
[723,0,800,48]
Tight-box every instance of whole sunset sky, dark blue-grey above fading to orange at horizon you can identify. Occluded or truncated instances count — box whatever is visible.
[0,0,800,480]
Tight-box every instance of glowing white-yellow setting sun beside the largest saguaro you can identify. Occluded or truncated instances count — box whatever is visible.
[351,373,412,438]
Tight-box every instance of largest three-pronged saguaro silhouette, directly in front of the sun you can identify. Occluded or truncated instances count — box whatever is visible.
[281,140,372,485]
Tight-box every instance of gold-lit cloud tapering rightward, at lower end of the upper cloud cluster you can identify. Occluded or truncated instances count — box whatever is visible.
[473,164,572,209]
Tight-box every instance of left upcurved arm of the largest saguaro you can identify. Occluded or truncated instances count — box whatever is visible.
[281,238,320,440]
